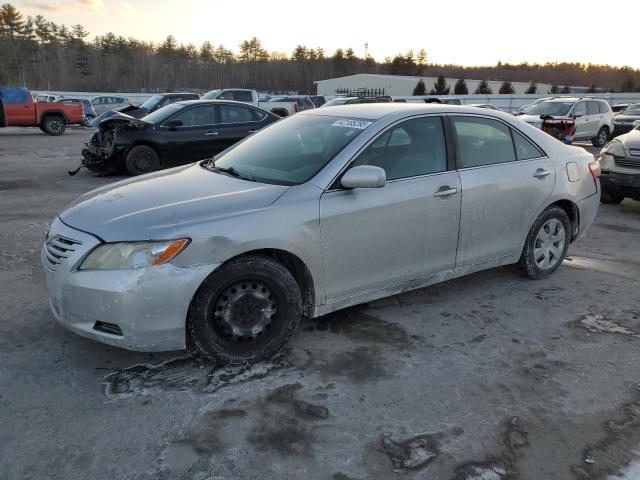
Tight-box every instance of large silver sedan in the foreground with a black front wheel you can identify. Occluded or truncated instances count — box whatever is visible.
[42,104,600,363]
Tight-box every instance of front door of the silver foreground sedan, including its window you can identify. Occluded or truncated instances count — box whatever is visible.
[320,116,461,302]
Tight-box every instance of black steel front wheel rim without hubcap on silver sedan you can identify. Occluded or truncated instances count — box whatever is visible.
[212,280,278,344]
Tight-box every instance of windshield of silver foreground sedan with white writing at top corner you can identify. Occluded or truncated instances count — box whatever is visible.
[208,114,373,185]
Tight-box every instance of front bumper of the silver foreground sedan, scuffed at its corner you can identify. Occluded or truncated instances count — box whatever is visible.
[42,219,217,352]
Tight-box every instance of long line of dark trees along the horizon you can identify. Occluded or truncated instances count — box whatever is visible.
[0,4,640,95]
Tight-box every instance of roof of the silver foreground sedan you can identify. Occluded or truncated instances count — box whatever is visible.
[296,102,515,120]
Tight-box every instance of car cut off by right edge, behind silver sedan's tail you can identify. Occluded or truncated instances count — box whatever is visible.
[598,126,640,204]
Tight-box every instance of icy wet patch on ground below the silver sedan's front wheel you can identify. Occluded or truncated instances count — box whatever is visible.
[104,355,288,399]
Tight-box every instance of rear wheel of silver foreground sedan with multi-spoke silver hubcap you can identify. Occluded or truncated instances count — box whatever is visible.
[519,207,571,280]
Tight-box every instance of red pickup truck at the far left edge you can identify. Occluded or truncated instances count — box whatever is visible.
[0,87,85,135]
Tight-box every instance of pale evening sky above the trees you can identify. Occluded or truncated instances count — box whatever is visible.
[9,0,640,68]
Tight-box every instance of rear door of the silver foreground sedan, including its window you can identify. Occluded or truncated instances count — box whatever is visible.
[450,115,555,271]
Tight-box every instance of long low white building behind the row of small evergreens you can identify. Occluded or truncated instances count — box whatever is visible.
[314,73,551,96]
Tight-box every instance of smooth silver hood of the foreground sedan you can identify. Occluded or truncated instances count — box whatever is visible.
[60,163,289,242]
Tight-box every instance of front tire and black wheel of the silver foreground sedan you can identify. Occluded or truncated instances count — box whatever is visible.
[187,256,302,365]
